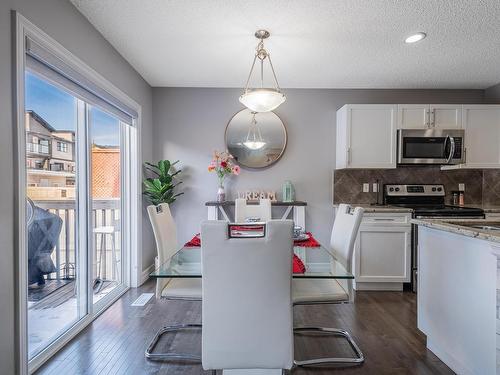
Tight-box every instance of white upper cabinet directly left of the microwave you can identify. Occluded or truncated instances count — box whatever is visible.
[336,104,397,169]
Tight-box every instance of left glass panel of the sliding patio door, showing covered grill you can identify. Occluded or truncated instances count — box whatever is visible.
[25,72,88,359]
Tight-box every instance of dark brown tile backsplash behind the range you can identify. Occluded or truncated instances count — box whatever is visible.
[333,166,500,205]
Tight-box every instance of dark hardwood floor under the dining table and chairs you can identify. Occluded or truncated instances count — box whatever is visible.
[36,281,453,375]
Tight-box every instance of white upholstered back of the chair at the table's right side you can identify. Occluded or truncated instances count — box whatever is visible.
[330,204,364,272]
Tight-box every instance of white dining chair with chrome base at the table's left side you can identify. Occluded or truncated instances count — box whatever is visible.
[145,203,202,362]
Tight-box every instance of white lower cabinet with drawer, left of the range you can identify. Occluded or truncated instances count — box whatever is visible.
[353,213,411,290]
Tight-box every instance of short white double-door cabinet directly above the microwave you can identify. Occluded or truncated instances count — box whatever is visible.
[398,104,462,129]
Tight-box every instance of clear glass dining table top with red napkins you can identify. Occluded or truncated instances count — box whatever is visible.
[149,246,354,279]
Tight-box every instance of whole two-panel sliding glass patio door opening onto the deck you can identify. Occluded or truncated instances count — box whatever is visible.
[25,72,131,360]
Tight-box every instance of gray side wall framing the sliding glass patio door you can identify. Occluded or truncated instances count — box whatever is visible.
[0,0,154,375]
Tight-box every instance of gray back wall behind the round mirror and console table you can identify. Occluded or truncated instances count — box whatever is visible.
[153,88,484,250]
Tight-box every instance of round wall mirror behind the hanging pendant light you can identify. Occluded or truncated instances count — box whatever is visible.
[226,108,287,168]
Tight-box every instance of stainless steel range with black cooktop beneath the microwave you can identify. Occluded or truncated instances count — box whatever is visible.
[384,184,484,292]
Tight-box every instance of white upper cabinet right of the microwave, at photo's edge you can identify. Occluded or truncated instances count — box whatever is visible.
[462,105,500,168]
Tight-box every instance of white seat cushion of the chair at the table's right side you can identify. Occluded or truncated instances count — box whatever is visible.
[292,279,349,303]
